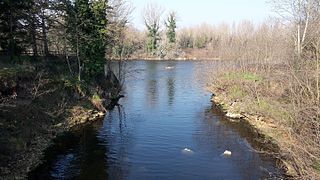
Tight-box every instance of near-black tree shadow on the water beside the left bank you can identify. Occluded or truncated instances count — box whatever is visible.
[29,122,109,179]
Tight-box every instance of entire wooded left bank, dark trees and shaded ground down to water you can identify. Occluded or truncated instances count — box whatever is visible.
[0,0,131,179]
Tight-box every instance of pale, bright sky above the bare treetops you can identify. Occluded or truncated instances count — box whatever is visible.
[129,0,272,29]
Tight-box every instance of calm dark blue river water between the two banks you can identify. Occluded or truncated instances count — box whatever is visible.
[29,61,281,180]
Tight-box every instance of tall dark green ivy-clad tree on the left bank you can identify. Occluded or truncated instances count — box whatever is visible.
[67,0,107,79]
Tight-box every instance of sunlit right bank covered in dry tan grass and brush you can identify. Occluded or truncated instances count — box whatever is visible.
[208,65,320,179]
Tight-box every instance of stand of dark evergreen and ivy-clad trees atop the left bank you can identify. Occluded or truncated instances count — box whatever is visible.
[0,0,130,80]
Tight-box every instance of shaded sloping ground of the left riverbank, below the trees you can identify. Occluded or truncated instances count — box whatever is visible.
[0,59,119,179]
